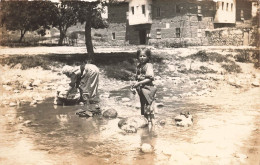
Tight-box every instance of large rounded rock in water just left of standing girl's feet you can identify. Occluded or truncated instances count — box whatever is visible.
[118,116,148,133]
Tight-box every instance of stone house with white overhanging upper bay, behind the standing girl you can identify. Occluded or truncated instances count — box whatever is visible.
[127,0,215,45]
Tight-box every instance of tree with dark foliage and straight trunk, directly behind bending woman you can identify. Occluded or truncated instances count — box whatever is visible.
[70,0,108,61]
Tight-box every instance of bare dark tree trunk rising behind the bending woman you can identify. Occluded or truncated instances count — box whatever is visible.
[85,22,94,61]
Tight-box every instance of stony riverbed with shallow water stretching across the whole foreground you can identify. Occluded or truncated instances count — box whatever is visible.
[0,47,260,165]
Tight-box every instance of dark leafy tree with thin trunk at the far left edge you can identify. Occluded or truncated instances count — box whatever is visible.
[1,1,54,42]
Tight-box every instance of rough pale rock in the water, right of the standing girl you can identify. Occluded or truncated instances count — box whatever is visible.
[174,112,193,127]
